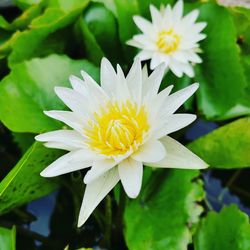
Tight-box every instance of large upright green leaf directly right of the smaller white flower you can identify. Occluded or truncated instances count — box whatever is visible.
[196,3,246,119]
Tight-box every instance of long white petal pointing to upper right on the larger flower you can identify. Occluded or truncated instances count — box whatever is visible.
[163,83,199,115]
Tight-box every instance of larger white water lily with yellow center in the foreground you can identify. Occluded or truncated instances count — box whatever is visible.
[36,59,207,226]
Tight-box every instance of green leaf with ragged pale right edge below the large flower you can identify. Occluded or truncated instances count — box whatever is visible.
[125,169,203,250]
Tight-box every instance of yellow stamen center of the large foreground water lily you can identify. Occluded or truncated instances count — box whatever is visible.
[84,101,149,157]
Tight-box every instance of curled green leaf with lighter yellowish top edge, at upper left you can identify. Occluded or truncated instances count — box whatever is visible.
[8,0,88,66]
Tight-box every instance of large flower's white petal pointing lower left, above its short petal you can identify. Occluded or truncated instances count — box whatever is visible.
[41,149,93,177]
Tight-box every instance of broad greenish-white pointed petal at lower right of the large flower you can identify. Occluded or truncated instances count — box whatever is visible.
[145,136,208,169]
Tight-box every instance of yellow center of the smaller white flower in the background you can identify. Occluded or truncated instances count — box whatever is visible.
[156,29,181,54]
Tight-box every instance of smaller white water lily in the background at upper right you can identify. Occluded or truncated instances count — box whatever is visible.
[127,0,206,77]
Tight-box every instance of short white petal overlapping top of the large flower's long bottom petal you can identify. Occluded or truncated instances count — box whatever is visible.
[84,159,117,184]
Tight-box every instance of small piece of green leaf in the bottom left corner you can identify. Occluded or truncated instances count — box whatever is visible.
[0,227,16,250]
